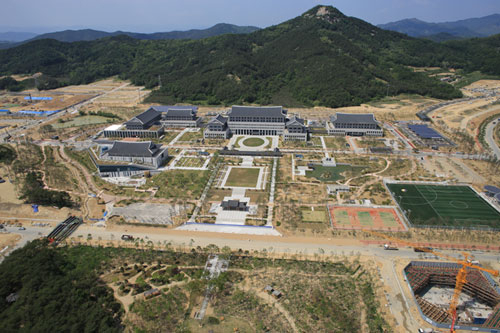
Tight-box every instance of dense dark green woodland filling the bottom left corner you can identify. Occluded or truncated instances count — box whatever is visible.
[0,240,123,332]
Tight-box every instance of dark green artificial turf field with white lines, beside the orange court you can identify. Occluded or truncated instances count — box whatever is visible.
[387,184,500,229]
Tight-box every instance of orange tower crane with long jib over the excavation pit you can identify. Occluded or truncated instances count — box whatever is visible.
[363,230,499,333]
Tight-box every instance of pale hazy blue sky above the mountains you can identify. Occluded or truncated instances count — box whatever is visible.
[0,0,500,33]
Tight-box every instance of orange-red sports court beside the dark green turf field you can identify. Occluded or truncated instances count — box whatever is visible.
[328,206,407,231]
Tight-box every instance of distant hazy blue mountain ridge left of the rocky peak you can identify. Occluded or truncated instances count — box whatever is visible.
[26,23,259,42]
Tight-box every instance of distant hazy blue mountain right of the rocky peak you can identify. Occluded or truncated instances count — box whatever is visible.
[378,14,500,40]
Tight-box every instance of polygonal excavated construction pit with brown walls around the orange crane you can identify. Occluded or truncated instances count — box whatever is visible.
[404,261,500,332]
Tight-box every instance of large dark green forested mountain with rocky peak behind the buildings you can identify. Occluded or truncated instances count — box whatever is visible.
[0,7,500,107]
